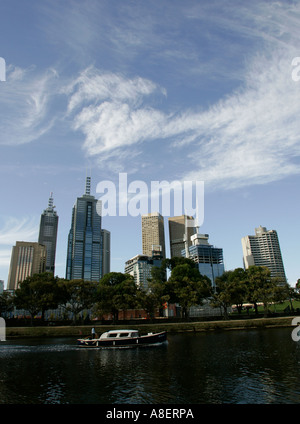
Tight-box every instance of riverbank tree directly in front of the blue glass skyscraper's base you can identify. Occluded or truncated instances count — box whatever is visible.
[59,279,97,322]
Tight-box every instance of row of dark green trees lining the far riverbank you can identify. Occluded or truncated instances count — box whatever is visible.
[7,264,300,321]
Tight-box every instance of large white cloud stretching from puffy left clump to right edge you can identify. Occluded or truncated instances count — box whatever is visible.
[64,45,300,188]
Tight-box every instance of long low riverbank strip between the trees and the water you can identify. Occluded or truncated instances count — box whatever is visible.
[6,316,294,340]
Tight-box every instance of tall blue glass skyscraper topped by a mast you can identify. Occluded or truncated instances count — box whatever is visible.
[66,177,108,281]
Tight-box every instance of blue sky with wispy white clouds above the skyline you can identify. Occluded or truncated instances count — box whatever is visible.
[0,0,300,286]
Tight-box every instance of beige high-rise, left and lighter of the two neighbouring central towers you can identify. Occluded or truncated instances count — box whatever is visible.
[142,212,166,259]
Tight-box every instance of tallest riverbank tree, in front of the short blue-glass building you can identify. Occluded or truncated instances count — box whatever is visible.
[165,258,211,318]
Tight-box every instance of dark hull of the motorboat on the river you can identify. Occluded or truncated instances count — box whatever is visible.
[77,331,167,348]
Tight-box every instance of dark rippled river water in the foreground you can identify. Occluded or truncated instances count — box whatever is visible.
[0,328,300,405]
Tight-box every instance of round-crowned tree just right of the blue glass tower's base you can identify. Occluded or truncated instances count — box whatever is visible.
[96,272,138,321]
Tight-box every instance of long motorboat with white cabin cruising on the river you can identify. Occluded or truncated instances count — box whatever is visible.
[77,330,167,348]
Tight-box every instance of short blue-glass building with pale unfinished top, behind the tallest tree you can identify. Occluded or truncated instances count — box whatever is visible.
[182,233,224,288]
